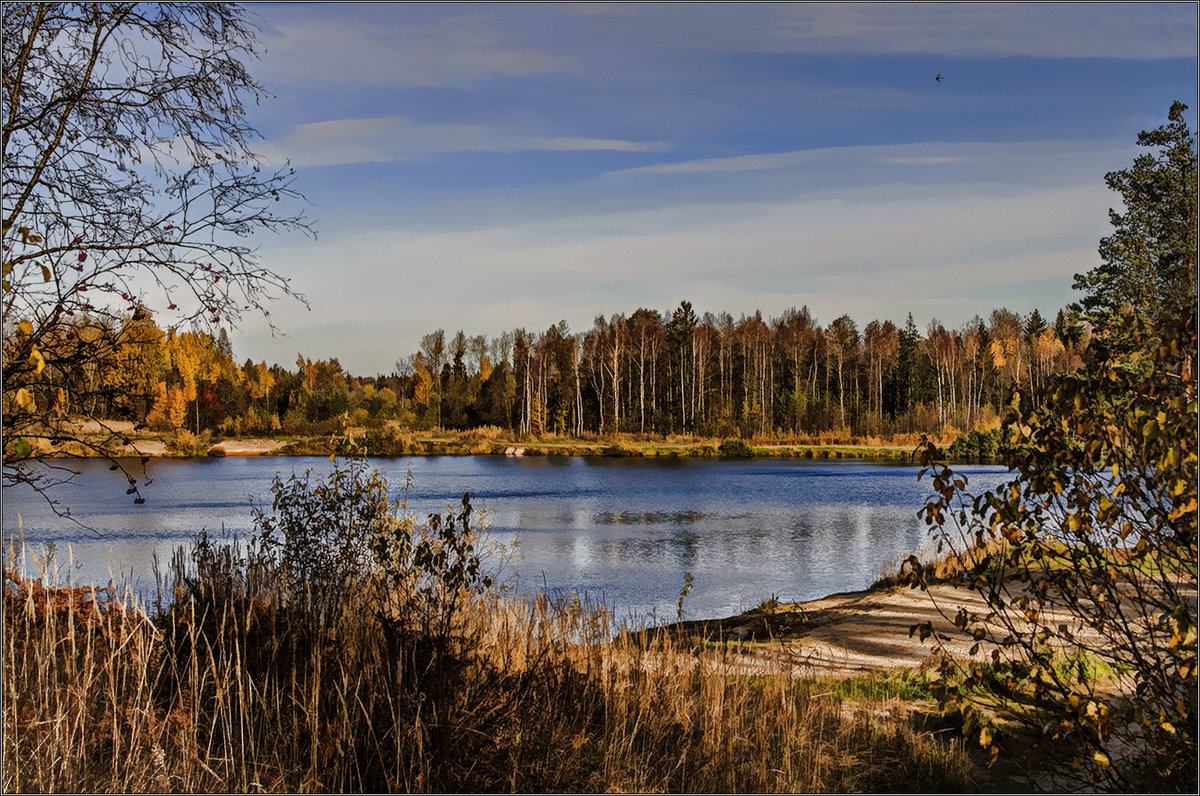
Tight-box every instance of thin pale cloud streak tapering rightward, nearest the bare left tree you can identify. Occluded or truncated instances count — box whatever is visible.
[262,115,671,166]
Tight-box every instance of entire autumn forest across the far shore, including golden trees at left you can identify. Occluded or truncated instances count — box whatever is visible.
[16,300,1091,449]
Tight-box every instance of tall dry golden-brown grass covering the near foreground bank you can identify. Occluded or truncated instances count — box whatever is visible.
[2,549,972,792]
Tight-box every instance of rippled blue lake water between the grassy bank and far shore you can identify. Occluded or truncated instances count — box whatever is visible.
[4,456,1004,620]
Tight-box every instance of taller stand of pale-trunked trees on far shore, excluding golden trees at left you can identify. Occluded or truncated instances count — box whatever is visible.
[397,300,1090,437]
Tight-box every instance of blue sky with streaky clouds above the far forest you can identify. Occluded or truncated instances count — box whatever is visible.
[232,2,1200,376]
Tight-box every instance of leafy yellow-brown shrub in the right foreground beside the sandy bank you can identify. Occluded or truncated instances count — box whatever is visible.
[907,316,1196,791]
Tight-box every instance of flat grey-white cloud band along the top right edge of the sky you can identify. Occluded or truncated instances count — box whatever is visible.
[554,2,1196,59]
